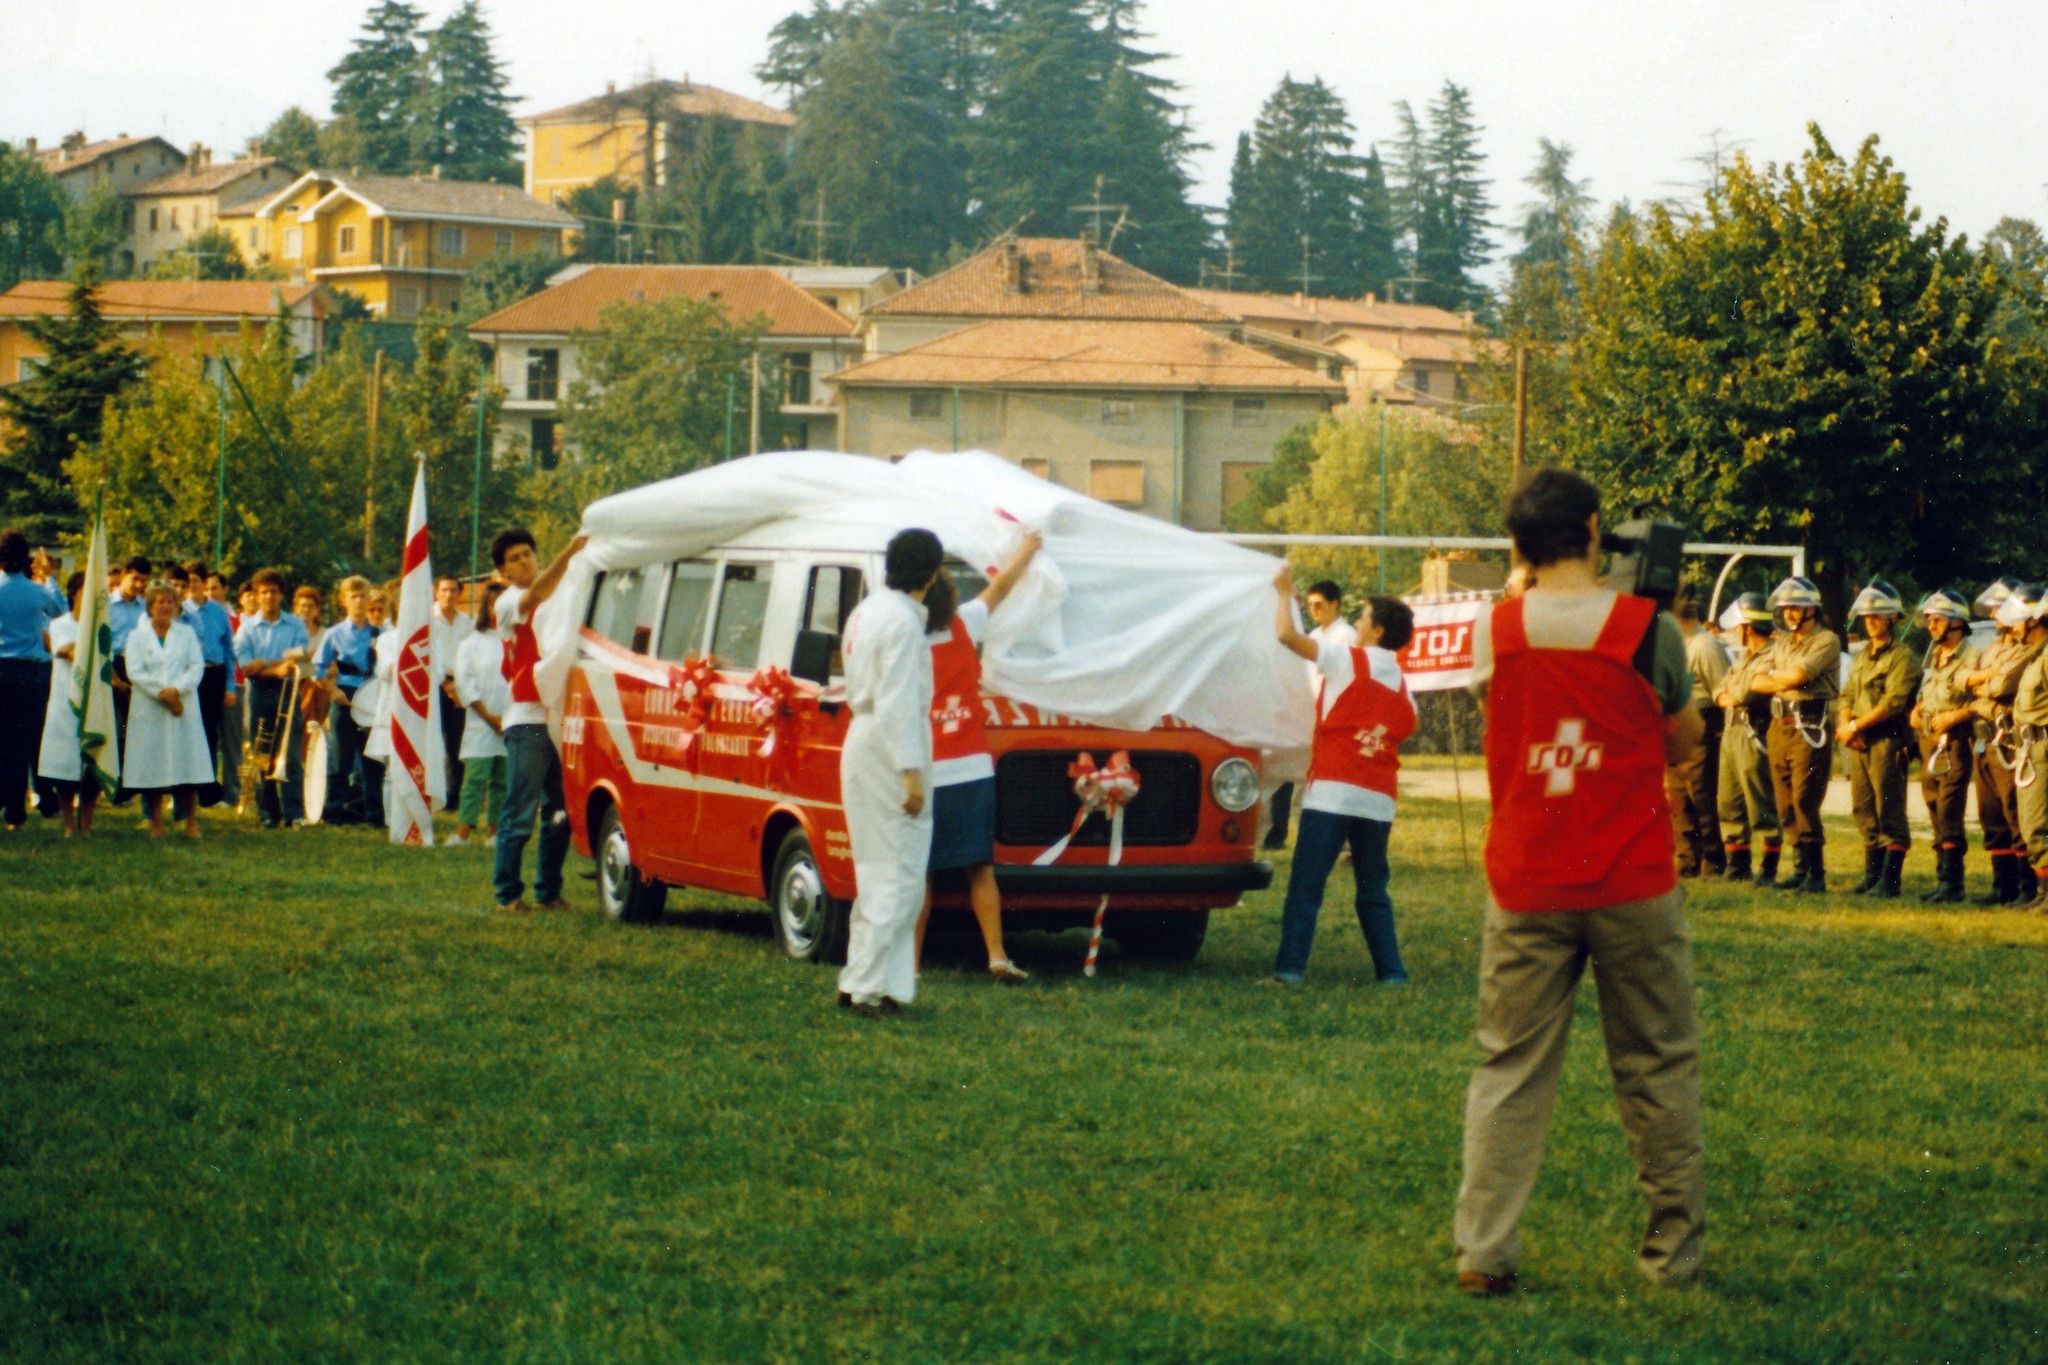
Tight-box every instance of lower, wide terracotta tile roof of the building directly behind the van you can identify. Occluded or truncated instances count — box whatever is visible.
[823,319,1343,397]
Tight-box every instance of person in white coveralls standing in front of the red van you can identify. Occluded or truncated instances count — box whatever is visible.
[840,530,946,1015]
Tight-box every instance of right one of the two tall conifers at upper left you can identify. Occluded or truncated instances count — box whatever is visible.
[414,0,520,184]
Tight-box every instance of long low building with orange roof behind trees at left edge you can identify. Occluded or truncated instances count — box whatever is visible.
[0,280,328,385]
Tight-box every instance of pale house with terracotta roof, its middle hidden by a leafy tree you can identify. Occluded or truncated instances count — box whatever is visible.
[469,266,860,467]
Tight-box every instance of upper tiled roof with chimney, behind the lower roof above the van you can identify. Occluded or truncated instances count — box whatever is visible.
[868,237,1233,323]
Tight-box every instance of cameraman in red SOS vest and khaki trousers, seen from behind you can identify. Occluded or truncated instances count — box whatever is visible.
[1454,469,1706,1295]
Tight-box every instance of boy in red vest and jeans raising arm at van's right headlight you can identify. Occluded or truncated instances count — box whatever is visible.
[1266,569,1415,986]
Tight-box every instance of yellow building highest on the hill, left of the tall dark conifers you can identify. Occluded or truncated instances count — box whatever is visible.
[518,78,797,205]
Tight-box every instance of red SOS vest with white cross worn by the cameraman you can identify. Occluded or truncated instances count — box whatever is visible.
[1487,596,1677,913]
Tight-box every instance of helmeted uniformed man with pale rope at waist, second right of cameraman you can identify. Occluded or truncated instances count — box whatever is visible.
[1749,579,1841,892]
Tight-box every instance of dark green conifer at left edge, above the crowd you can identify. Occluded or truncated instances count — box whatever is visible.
[0,270,143,540]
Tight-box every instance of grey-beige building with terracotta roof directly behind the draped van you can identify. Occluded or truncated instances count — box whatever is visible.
[831,319,1343,530]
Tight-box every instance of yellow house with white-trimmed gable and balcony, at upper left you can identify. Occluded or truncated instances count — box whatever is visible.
[254,170,575,319]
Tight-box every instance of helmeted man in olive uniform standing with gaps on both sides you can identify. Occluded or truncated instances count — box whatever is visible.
[1835,579,1921,900]
